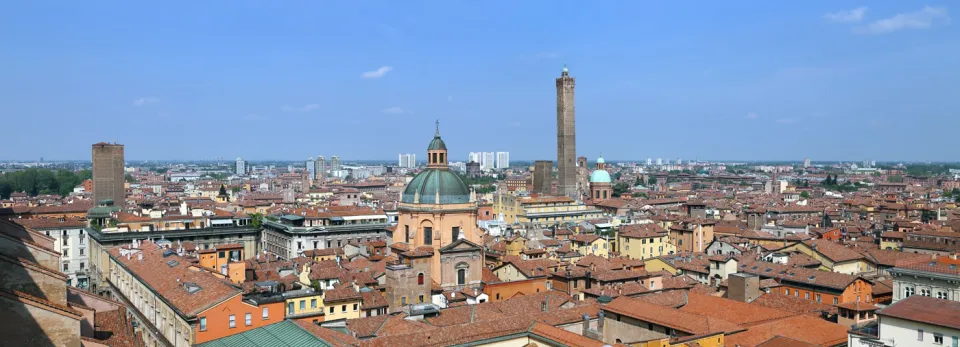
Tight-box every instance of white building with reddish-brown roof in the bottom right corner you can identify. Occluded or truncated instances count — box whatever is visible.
[847,295,960,347]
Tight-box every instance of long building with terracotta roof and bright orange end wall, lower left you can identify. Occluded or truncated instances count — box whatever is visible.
[107,241,284,346]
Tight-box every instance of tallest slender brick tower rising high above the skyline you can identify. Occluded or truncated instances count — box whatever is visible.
[557,65,577,199]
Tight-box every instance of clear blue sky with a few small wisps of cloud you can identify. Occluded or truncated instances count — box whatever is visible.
[0,1,960,161]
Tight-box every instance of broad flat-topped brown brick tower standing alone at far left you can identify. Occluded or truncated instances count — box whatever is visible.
[93,142,126,206]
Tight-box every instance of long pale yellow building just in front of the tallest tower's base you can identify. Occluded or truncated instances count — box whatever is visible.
[493,193,603,225]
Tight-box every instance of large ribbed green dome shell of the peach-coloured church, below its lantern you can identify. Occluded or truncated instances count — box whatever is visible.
[400,170,470,204]
